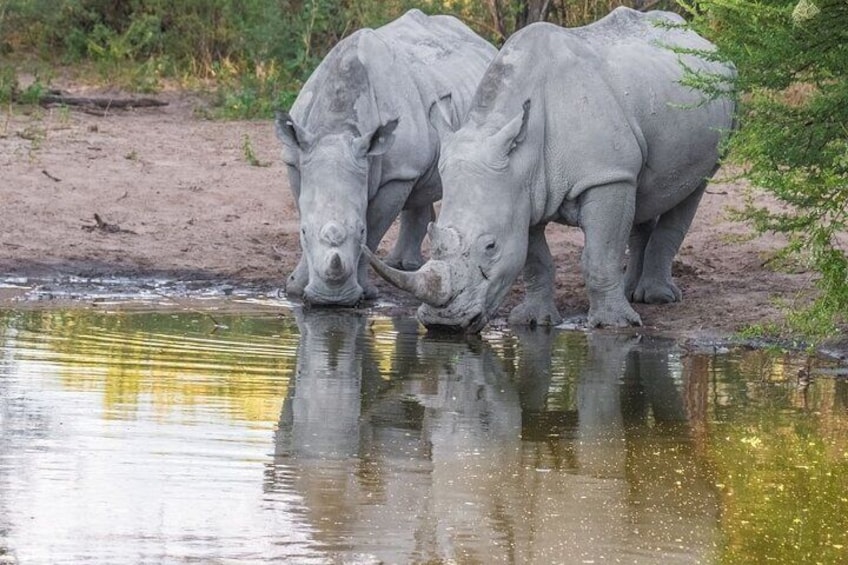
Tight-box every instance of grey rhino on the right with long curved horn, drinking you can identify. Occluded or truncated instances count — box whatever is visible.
[372,8,735,332]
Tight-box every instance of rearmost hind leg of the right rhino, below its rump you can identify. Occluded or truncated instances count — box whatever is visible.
[632,182,706,304]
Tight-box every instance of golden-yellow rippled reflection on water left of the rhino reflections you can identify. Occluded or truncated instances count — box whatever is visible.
[2,311,298,422]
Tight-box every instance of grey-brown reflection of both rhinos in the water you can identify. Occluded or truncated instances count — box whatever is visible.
[269,317,716,563]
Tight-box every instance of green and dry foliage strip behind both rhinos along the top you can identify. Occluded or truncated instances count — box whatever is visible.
[0,0,672,118]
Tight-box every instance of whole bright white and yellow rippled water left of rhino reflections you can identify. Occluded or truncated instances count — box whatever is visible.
[0,311,308,564]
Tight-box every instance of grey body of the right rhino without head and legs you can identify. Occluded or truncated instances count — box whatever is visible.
[468,8,734,221]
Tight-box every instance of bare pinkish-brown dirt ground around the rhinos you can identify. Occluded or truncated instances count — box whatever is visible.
[0,88,836,350]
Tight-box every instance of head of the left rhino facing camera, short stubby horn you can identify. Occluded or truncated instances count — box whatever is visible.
[276,110,398,305]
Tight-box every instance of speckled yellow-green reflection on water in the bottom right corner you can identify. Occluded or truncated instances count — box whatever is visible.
[707,351,848,563]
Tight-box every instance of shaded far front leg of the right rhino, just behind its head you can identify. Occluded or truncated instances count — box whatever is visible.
[509,224,562,326]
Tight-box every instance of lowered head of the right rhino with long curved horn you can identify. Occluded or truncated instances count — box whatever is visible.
[369,104,530,333]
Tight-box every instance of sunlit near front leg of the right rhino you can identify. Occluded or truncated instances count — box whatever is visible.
[580,183,642,327]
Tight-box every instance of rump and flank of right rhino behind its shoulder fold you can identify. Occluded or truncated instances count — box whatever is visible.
[575,8,735,221]
